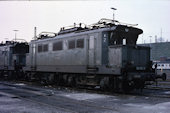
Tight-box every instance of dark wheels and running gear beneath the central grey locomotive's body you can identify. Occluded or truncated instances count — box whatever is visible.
[25,72,125,91]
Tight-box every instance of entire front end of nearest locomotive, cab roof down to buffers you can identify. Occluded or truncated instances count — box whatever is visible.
[103,25,159,90]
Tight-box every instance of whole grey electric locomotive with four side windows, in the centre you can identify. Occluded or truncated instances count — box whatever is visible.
[0,19,163,91]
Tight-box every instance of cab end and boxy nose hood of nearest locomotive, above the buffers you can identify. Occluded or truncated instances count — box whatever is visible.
[108,26,150,72]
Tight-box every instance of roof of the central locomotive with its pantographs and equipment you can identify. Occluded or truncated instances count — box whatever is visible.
[32,19,143,41]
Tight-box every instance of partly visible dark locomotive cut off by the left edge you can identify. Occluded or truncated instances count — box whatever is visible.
[0,41,29,79]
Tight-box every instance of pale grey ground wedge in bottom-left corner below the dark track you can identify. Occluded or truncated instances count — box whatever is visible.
[0,96,67,113]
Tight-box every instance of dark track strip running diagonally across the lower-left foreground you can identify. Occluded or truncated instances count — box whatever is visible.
[0,82,117,113]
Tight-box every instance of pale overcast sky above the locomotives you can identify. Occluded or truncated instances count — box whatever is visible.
[0,0,170,43]
